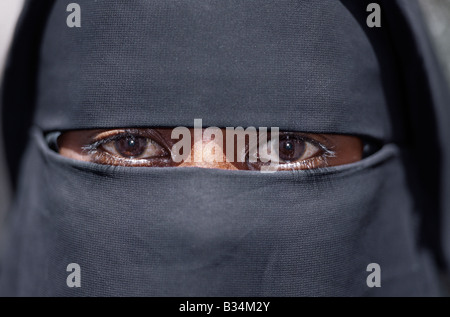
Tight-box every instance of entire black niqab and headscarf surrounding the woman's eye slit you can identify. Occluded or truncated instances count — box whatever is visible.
[0,0,450,296]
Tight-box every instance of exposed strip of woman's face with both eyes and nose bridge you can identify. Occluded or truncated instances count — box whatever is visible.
[58,128,363,170]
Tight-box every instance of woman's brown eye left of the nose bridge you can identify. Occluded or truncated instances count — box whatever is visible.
[100,135,167,159]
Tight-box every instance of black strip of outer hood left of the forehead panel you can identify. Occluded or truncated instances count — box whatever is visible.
[1,0,53,187]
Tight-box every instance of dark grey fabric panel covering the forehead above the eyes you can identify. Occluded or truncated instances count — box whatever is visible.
[36,1,390,139]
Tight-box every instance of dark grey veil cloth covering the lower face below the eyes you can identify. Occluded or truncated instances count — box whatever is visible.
[0,131,437,296]
